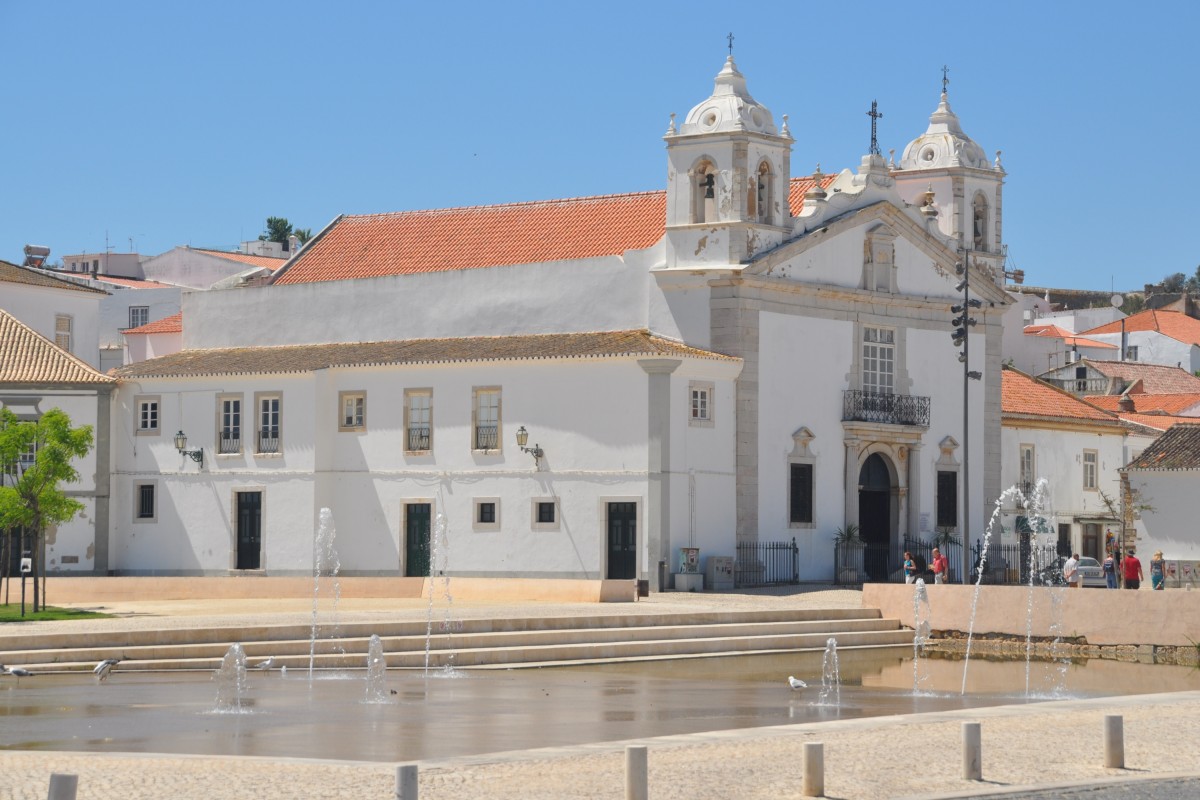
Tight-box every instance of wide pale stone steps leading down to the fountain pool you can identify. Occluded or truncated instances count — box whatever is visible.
[0,608,913,672]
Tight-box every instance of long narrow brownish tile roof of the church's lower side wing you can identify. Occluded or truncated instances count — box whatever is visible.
[113,330,738,378]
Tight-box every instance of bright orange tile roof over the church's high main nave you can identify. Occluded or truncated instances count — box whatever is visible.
[272,175,836,283]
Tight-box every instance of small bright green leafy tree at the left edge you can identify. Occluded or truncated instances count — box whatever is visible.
[0,408,92,612]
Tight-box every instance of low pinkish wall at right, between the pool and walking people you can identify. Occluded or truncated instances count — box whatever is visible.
[863,583,1200,648]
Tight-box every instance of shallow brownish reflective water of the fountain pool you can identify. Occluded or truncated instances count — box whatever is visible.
[0,646,1200,762]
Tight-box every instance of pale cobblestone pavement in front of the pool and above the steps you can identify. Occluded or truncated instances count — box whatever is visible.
[0,590,1200,800]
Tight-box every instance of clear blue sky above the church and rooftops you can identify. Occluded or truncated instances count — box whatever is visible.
[0,0,1200,290]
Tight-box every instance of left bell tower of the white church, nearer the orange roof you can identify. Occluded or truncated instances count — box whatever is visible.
[662,55,792,269]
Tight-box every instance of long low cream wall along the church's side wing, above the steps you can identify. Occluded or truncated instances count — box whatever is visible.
[30,575,637,606]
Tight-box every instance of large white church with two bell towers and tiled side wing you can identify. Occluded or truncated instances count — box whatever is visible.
[96,55,1010,590]
